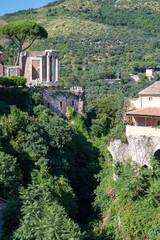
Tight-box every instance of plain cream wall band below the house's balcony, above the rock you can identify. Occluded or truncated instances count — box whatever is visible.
[126,125,160,137]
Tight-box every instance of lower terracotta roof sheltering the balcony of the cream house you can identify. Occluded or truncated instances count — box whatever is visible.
[126,107,160,117]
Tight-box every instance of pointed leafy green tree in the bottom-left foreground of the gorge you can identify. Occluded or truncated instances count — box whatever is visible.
[15,167,82,240]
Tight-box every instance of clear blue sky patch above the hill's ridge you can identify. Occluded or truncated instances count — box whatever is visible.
[0,0,54,16]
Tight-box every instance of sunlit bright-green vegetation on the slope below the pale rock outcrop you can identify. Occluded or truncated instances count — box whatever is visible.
[92,159,160,240]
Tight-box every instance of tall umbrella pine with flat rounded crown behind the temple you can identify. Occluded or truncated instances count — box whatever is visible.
[0,20,48,65]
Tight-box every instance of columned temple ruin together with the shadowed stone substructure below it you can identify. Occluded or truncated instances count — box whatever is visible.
[0,50,84,116]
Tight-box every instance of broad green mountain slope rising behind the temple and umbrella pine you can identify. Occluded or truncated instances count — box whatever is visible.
[0,0,160,85]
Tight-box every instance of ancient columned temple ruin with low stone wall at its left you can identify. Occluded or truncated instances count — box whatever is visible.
[0,50,59,86]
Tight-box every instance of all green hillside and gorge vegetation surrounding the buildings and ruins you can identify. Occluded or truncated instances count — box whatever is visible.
[0,0,160,240]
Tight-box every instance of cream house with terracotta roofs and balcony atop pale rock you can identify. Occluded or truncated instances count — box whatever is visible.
[126,81,160,137]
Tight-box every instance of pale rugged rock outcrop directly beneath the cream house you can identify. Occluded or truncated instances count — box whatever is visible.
[108,136,160,166]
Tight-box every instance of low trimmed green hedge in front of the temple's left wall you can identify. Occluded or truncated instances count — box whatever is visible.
[0,76,27,87]
